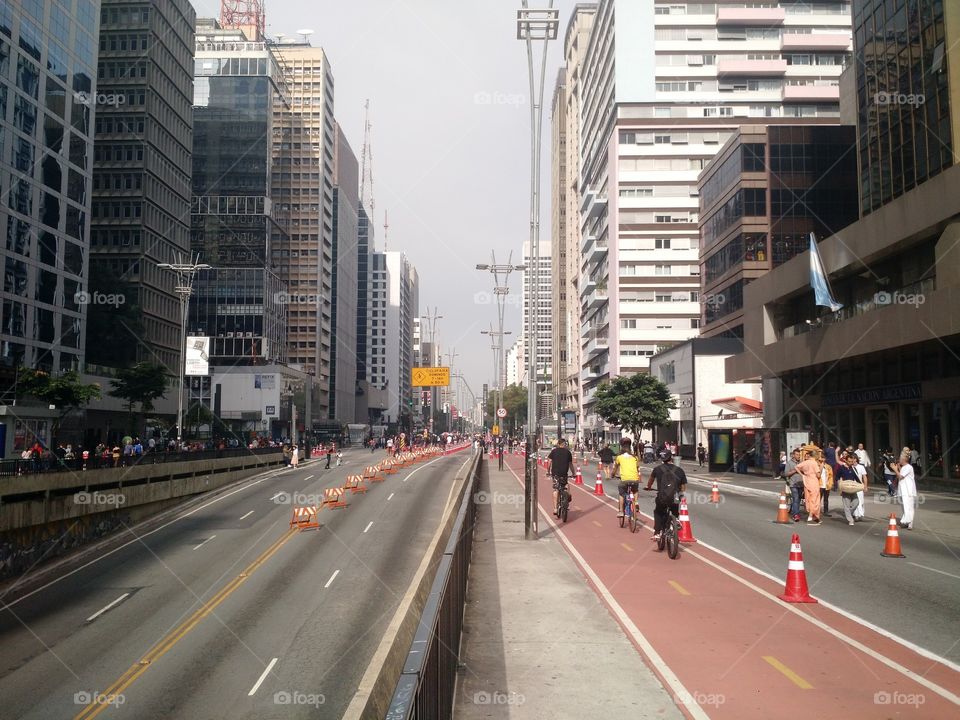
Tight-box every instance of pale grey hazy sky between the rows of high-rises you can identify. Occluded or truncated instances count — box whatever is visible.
[192,0,575,402]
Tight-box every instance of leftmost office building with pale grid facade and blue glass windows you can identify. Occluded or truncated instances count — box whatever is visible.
[0,0,100,453]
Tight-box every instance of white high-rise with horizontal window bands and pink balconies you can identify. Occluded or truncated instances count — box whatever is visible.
[580,0,850,432]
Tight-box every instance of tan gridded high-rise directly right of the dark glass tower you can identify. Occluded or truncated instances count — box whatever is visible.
[273,37,336,417]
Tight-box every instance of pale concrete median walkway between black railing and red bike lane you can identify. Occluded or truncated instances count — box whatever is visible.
[453,460,683,720]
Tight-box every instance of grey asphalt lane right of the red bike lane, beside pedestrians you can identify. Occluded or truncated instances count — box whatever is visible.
[580,458,960,664]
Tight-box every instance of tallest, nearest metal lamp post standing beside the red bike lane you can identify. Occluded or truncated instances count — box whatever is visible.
[517,0,560,540]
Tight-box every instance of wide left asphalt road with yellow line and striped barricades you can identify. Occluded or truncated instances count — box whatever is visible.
[0,451,469,720]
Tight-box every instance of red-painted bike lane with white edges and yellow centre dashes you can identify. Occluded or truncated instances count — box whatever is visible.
[507,457,960,720]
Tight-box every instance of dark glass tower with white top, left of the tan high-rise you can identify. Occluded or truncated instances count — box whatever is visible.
[188,19,288,365]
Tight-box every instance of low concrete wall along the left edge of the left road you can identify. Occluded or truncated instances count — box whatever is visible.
[0,452,283,579]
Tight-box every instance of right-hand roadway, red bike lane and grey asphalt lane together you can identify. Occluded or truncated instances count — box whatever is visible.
[508,457,960,718]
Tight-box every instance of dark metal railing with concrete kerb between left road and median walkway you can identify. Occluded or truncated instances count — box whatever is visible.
[384,455,485,720]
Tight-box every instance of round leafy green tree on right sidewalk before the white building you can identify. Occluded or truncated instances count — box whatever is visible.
[594,374,677,438]
